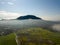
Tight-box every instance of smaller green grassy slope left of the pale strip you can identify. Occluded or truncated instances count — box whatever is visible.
[0,33,17,45]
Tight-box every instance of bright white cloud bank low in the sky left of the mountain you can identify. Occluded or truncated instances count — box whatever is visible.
[0,11,22,19]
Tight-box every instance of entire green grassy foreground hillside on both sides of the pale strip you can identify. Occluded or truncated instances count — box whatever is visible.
[0,28,60,45]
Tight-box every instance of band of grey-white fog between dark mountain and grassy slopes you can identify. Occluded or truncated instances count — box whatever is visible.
[0,19,60,31]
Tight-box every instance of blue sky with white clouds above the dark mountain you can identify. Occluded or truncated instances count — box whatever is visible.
[0,0,60,21]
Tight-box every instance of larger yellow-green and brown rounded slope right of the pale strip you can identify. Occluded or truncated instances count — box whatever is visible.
[16,28,60,45]
